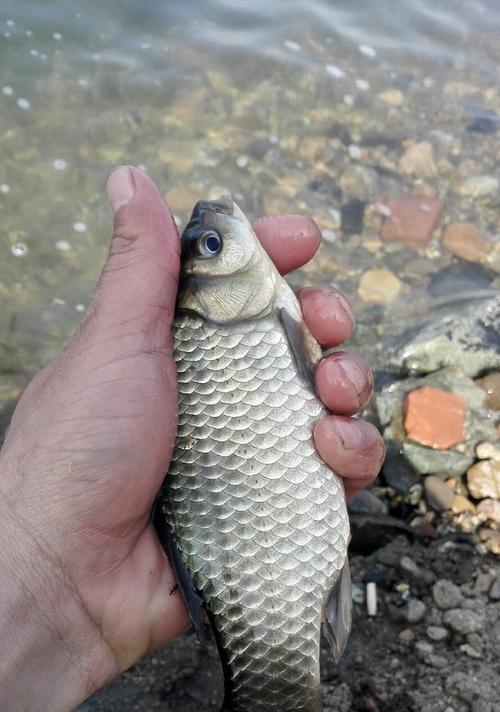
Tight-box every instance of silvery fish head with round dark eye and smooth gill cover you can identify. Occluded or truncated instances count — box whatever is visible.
[177,196,281,323]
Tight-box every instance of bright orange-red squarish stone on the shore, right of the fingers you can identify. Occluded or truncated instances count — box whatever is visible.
[404,386,465,450]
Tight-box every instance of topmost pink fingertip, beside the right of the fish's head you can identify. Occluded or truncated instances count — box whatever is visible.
[253,215,321,274]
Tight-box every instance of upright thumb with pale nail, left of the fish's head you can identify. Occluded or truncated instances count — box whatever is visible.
[90,166,180,350]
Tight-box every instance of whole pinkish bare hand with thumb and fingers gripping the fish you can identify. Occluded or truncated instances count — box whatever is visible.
[0,167,383,712]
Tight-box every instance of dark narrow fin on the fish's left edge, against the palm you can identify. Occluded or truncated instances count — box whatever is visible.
[151,496,206,643]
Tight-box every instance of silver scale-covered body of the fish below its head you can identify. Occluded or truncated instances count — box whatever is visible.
[162,315,348,712]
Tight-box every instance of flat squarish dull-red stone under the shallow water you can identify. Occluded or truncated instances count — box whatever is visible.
[380,195,443,247]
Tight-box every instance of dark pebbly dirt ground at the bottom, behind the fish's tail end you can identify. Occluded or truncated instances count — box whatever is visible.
[79,532,500,712]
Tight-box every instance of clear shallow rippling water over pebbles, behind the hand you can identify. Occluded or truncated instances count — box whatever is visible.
[0,0,500,403]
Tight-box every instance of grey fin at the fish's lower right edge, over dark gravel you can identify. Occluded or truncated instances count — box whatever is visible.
[323,556,352,663]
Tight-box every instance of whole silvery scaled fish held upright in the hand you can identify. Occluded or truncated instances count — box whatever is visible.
[154,196,352,712]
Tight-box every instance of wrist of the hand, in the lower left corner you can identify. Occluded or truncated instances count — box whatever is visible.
[0,492,119,712]
